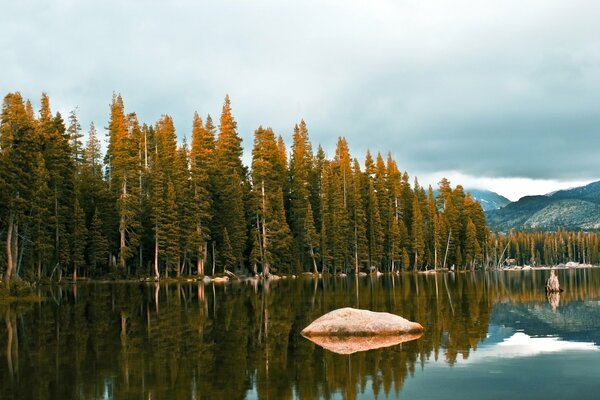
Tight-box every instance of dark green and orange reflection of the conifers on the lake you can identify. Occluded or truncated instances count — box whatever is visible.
[0,270,600,399]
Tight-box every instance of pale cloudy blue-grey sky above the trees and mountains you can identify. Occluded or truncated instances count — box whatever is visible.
[0,0,600,200]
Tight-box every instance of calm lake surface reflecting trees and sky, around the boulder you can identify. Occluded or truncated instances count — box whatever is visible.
[0,268,600,400]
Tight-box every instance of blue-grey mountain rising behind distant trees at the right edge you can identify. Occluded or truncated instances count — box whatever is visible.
[486,181,600,231]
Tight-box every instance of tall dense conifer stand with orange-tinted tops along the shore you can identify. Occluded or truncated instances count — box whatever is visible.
[0,93,576,281]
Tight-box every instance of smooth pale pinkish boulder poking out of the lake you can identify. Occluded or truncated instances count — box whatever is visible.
[302,307,423,337]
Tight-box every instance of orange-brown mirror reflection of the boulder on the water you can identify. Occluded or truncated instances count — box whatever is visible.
[307,333,423,354]
